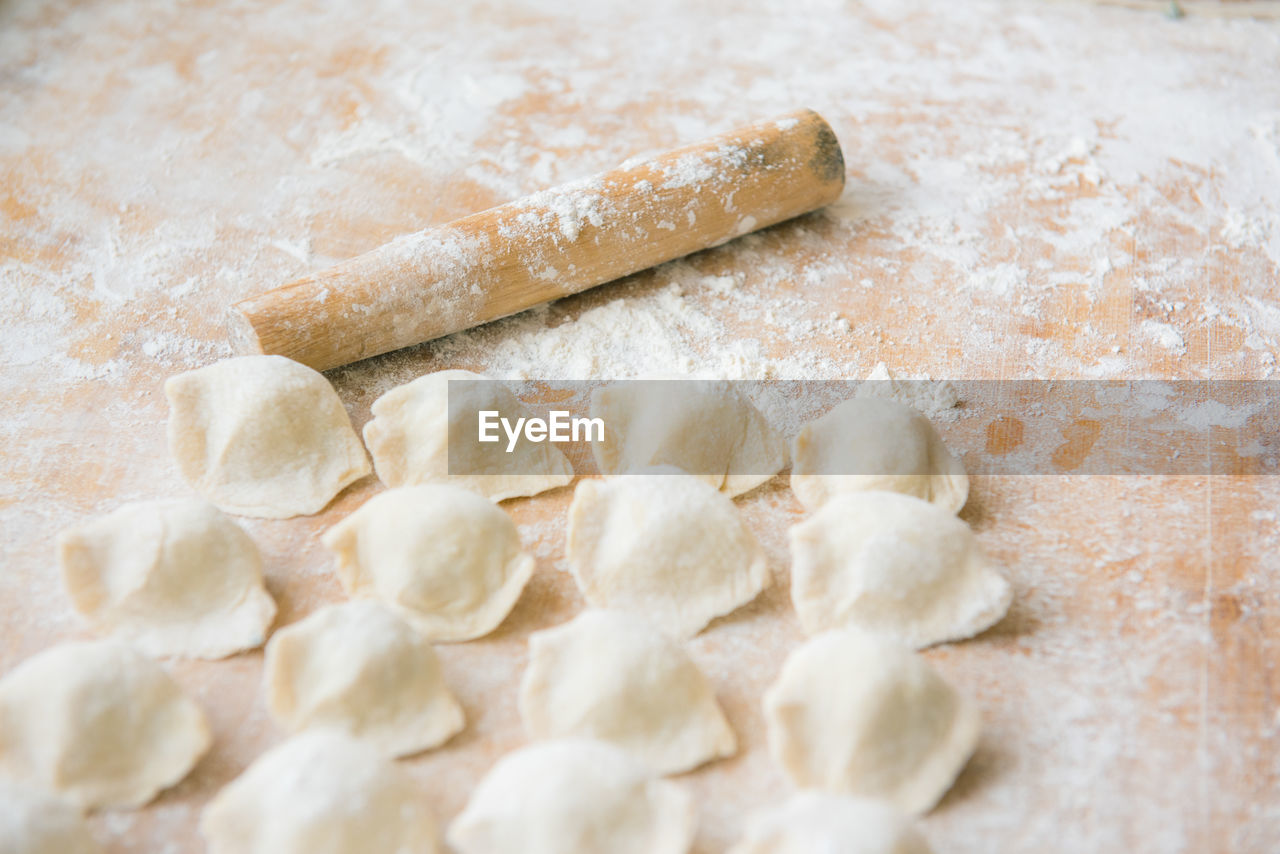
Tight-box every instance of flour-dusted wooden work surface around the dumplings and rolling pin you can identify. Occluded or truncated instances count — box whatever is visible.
[0,0,1280,854]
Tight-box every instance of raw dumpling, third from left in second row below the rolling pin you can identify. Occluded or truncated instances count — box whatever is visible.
[567,467,769,638]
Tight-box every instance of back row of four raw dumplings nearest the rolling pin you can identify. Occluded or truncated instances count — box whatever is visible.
[165,356,968,519]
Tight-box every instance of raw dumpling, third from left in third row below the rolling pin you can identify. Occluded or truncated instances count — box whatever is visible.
[520,611,737,773]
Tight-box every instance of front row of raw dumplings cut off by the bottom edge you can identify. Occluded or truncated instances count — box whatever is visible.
[0,729,929,854]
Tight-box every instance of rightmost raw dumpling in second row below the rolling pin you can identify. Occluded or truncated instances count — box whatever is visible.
[790,492,1012,648]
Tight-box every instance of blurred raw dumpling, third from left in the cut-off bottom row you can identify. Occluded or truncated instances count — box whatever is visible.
[448,739,695,854]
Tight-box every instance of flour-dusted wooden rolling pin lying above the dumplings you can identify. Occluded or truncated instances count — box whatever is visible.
[228,110,845,370]
